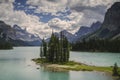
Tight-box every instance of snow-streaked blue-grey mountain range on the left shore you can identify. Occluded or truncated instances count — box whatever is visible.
[0,21,41,46]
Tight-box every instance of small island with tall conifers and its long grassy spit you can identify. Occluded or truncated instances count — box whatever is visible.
[32,33,120,76]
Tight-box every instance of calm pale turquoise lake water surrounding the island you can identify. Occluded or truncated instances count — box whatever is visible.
[0,47,120,80]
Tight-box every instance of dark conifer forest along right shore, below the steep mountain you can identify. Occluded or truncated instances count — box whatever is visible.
[72,39,120,52]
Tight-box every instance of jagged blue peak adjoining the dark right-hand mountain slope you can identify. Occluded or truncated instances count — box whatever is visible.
[75,21,101,40]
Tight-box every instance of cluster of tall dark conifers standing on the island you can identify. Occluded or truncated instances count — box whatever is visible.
[40,32,70,63]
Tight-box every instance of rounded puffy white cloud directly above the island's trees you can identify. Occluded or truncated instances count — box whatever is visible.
[48,18,78,33]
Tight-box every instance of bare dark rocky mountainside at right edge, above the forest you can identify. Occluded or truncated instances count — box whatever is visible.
[87,2,120,40]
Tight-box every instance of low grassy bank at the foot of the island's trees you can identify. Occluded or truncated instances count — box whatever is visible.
[32,58,120,73]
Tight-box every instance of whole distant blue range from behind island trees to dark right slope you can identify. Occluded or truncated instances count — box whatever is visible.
[46,21,101,43]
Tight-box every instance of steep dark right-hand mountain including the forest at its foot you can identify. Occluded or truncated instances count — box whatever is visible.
[72,2,120,53]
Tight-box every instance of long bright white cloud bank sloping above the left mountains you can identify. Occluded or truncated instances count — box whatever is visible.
[0,0,51,37]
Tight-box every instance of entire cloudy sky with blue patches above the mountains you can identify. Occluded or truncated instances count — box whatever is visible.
[0,0,120,38]
